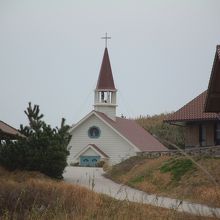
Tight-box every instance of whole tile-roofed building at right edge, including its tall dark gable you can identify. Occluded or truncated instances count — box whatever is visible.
[165,45,220,147]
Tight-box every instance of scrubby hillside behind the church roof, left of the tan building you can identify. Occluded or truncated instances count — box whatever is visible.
[136,113,184,148]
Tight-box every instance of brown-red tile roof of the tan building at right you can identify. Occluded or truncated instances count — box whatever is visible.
[165,91,217,122]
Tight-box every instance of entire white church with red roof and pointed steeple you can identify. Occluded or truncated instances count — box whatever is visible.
[68,47,167,166]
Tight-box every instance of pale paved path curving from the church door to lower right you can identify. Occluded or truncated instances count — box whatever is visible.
[63,167,220,218]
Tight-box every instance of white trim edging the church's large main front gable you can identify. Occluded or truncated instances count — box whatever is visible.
[69,110,142,152]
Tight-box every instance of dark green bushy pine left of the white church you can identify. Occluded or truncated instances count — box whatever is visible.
[0,103,70,179]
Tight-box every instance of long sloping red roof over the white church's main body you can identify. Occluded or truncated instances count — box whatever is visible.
[95,111,167,151]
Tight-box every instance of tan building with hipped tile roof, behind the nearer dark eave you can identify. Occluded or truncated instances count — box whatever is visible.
[165,91,220,147]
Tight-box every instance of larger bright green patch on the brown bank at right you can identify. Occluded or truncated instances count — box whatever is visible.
[160,158,195,182]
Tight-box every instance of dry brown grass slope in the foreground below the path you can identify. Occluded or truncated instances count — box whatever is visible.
[0,167,213,220]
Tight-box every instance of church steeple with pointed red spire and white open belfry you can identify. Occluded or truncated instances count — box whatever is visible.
[94,47,117,120]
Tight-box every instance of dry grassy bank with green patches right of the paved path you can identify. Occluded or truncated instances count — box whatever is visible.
[106,157,220,207]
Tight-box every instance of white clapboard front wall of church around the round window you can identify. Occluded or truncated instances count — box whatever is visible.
[68,115,136,165]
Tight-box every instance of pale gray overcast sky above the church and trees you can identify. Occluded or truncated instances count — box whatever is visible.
[0,0,220,127]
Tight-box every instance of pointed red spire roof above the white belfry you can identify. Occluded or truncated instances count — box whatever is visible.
[96,48,116,90]
